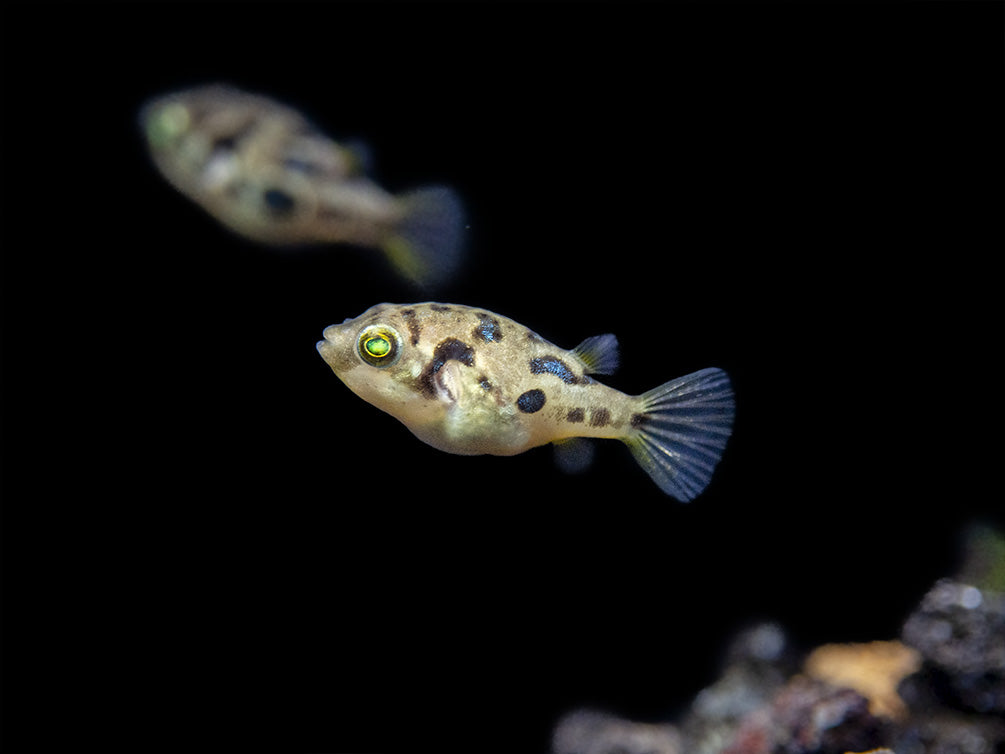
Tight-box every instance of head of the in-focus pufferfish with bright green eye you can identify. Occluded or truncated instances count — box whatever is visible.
[318,304,426,418]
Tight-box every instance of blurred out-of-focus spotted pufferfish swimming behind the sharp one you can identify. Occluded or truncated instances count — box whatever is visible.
[140,84,464,285]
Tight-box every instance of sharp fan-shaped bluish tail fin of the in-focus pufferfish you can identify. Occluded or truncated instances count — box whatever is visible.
[622,369,735,503]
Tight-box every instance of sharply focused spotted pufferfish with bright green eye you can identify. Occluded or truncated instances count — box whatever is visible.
[318,303,734,502]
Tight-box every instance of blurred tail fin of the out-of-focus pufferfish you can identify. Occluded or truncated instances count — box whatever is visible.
[383,186,464,288]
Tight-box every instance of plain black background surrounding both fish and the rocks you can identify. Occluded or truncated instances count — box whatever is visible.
[2,3,1005,752]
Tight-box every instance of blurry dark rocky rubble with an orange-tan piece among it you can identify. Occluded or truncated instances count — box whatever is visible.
[553,579,1005,754]
